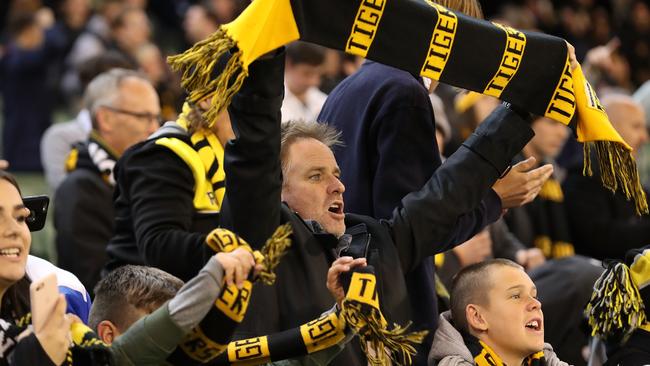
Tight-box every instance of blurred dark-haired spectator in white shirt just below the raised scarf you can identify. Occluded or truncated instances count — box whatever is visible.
[282,41,327,121]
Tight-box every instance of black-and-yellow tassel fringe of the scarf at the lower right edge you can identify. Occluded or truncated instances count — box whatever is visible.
[585,263,645,338]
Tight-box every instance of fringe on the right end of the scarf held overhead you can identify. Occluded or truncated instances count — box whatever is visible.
[582,141,648,215]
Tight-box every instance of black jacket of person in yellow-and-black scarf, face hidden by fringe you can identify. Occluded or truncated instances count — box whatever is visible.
[106,134,219,281]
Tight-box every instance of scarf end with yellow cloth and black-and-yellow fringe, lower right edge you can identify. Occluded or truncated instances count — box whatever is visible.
[586,246,650,341]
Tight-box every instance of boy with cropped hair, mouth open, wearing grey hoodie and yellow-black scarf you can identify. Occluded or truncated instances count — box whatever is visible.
[429,259,567,366]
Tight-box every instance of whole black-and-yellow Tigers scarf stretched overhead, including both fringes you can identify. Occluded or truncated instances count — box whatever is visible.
[168,0,648,213]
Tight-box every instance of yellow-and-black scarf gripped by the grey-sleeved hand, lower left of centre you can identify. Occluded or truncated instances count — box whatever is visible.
[167,224,292,365]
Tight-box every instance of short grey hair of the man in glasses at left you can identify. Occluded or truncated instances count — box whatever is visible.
[84,68,149,127]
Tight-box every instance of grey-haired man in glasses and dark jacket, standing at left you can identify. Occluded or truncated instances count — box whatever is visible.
[54,69,160,289]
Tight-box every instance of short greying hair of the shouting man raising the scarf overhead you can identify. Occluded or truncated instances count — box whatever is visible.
[280,120,343,171]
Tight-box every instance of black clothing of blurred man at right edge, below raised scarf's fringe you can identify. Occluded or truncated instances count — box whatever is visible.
[564,172,650,259]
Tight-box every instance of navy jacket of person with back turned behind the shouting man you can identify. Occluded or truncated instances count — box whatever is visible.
[318,61,501,365]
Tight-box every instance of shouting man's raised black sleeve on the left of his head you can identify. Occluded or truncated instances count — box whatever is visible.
[221,52,284,248]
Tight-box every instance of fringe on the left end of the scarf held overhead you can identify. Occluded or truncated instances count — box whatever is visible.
[167,28,248,126]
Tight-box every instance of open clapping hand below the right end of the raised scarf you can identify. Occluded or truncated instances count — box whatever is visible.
[492,157,553,209]
